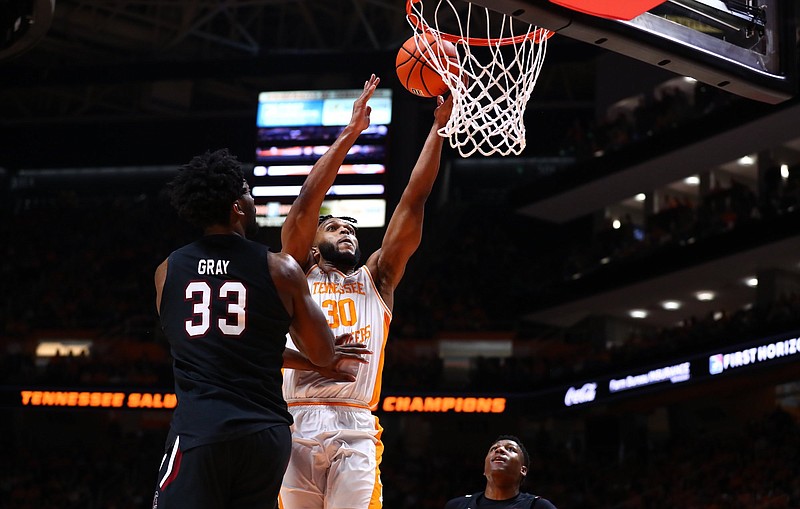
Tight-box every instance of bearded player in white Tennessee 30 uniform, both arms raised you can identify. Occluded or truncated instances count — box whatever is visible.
[280,75,452,509]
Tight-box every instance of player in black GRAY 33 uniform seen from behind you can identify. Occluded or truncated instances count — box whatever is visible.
[152,149,357,509]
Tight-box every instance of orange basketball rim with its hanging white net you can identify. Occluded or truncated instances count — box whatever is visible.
[406,0,553,157]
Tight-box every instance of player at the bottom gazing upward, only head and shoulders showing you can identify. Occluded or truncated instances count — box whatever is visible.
[444,435,556,509]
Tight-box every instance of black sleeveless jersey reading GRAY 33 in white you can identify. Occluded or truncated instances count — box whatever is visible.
[160,235,292,450]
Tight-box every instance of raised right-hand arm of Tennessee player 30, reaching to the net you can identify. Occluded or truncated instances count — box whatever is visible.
[367,96,453,307]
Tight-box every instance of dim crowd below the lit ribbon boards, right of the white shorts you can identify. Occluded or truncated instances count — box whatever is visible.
[382,408,800,509]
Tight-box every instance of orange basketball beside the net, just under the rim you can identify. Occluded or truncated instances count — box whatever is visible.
[395,33,458,97]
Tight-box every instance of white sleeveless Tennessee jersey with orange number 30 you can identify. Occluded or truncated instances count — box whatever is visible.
[283,265,392,410]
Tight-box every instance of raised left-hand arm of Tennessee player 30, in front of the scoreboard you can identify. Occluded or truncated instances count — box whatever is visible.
[281,74,381,270]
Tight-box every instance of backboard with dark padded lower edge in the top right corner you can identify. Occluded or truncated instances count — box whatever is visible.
[472,0,800,104]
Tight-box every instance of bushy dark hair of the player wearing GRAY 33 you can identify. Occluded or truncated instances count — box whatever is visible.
[167,148,245,228]
